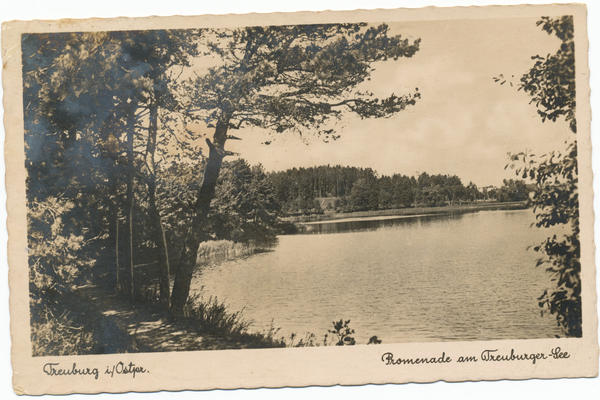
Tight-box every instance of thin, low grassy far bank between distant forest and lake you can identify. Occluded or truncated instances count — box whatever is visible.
[284,201,527,223]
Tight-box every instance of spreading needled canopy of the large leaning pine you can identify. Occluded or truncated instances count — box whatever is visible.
[184,24,419,138]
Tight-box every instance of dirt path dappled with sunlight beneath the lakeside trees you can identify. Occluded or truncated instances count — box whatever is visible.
[75,285,255,354]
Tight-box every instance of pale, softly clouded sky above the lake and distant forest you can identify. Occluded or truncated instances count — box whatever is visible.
[198,18,570,187]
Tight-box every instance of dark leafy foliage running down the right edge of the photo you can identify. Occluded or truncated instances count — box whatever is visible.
[502,15,582,337]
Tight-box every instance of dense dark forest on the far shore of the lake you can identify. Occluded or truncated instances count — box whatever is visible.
[269,165,531,215]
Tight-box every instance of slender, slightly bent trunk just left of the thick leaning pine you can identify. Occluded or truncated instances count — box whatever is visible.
[146,104,170,308]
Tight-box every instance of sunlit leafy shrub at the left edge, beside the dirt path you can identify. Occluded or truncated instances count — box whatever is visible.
[27,197,94,356]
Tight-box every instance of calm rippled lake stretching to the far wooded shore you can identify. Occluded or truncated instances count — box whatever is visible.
[192,210,560,344]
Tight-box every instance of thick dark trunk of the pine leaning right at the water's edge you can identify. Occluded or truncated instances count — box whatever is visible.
[171,117,229,314]
